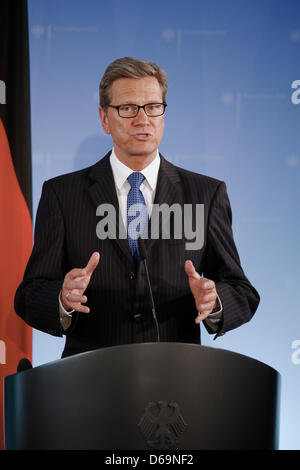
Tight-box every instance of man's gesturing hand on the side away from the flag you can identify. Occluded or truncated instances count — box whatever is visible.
[184,260,218,323]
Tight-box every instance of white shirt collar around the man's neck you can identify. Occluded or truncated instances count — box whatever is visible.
[110,149,160,191]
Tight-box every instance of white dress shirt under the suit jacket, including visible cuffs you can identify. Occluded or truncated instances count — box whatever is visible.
[59,149,222,333]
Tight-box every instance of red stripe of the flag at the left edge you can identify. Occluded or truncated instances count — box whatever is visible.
[0,119,33,448]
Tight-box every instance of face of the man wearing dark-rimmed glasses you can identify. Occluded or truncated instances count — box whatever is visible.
[100,77,164,166]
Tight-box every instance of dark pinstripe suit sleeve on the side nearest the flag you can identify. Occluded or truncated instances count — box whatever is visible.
[15,181,66,336]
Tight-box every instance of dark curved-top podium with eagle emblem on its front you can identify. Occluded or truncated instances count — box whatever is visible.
[5,343,280,450]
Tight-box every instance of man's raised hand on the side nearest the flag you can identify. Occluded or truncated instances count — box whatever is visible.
[60,251,100,313]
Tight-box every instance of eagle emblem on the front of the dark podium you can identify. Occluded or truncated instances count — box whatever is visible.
[138,401,187,450]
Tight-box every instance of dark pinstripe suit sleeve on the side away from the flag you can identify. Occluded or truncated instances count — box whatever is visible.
[203,182,260,338]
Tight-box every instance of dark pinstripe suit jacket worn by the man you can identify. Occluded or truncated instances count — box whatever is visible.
[15,152,259,357]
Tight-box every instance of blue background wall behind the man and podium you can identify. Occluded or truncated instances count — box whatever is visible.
[29,0,300,449]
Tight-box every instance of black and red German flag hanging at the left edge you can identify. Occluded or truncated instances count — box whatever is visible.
[0,0,33,449]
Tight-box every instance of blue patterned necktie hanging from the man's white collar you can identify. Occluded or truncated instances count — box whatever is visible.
[127,171,148,263]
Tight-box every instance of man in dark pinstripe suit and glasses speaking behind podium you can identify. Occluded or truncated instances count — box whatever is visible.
[15,57,259,356]
